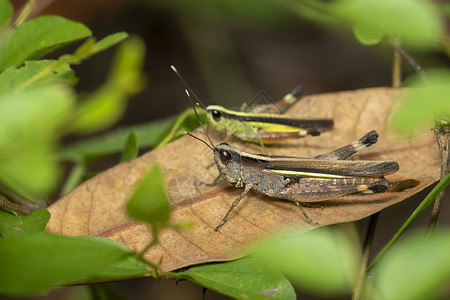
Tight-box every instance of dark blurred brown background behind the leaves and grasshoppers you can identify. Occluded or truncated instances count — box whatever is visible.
[5,0,449,299]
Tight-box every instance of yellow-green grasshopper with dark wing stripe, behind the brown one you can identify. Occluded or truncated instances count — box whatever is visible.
[171,66,333,145]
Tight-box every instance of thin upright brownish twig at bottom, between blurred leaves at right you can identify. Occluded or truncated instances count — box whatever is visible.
[352,213,379,300]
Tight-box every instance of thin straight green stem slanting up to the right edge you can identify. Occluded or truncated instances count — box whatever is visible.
[368,174,450,270]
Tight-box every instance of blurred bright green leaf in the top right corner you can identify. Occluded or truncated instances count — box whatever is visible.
[333,0,445,48]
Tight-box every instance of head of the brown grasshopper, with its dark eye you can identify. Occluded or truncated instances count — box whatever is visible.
[214,143,241,185]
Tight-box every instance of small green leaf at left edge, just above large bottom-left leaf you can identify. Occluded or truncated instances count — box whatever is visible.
[0,209,50,238]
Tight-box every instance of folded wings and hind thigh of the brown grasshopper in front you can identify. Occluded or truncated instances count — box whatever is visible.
[265,159,398,202]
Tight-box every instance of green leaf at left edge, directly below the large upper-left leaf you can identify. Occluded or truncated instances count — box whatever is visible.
[0,60,78,95]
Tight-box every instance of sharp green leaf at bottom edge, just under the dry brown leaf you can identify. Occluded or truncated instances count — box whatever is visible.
[173,257,296,299]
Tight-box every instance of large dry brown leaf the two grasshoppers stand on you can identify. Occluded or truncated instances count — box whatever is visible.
[47,88,440,271]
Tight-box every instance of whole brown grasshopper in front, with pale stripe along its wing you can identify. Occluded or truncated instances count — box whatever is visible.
[186,90,399,231]
